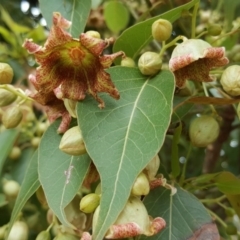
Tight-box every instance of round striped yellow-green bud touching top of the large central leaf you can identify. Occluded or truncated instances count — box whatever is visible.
[138,52,162,75]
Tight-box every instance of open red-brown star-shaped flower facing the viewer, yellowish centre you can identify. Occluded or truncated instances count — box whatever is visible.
[23,12,124,132]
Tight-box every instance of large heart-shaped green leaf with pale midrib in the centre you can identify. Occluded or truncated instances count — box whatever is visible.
[77,67,174,239]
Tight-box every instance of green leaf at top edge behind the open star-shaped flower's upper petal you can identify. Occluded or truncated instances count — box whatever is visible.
[39,0,91,38]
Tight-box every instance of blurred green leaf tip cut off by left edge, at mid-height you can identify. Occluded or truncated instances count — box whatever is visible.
[0,129,18,173]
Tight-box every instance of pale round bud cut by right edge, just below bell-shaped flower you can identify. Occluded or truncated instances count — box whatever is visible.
[220,65,240,96]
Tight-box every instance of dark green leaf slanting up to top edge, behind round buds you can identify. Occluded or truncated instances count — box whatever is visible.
[113,0,199,63]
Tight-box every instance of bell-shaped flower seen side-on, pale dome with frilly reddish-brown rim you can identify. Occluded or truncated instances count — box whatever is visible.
[169,39,229,88]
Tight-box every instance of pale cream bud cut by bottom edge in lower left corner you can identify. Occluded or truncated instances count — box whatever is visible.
[8,221,28,240]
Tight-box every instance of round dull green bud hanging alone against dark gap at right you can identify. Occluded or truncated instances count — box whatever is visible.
[189,115,220,147]
